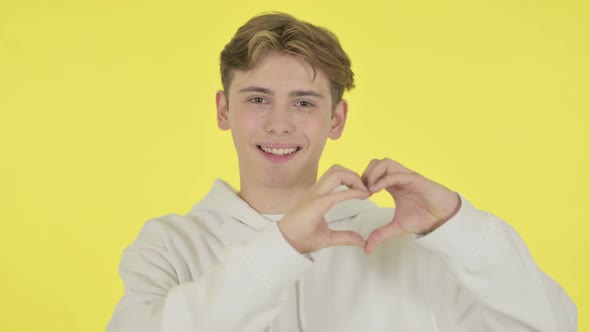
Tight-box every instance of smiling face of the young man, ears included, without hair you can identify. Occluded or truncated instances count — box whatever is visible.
[217,52,347,188]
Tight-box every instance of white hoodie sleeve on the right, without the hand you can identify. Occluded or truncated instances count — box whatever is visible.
[417,197,577,332]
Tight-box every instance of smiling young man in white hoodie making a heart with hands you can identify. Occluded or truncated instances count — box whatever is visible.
[107,14,577,332]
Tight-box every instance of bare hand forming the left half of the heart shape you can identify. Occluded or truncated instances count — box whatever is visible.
[279,165,371,253]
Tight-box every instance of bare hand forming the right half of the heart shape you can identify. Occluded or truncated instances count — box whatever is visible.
[362,158,461,254]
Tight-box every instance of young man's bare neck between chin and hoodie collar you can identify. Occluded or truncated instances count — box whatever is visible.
[239,179,315,214]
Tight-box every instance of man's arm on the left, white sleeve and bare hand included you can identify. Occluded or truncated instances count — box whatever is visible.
[107,167,369,332]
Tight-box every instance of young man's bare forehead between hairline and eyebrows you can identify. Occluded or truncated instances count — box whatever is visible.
[230,52,330,94]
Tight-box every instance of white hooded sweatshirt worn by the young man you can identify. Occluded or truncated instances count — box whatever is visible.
[107,180,577,332]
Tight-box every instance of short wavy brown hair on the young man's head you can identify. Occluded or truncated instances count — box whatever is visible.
[221,13,354,106]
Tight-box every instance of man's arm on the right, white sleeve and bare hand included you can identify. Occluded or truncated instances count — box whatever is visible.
[363,159,576,332]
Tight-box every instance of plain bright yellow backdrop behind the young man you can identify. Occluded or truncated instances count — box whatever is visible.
[0,0,590,331]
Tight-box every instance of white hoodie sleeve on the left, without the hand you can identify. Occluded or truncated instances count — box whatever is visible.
[107,222,312,332]
